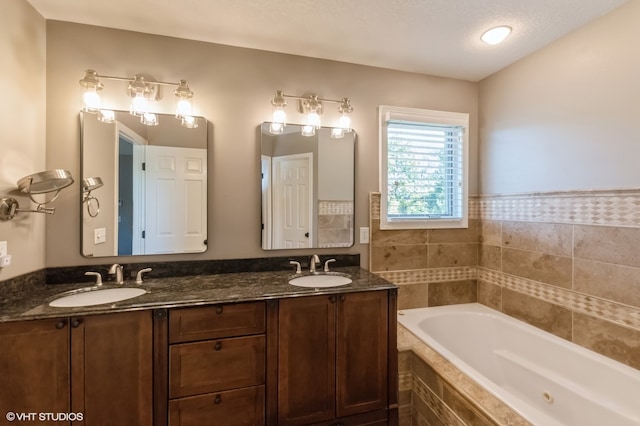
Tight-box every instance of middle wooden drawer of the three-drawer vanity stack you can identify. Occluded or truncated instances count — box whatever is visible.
[169,336,265,398]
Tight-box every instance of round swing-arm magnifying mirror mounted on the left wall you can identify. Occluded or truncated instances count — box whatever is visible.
[0,169,73,220]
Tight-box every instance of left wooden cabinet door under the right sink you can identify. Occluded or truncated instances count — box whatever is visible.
[278,295,336,426]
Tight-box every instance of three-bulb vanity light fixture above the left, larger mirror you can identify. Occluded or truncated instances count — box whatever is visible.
[79,70,198,128]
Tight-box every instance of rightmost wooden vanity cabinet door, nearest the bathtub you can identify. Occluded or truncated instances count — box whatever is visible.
[336,291,388,417]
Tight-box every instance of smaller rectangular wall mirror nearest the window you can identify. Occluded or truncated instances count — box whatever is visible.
[259,123,356,250]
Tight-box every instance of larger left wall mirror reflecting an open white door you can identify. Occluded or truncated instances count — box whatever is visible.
[80,111,208,257]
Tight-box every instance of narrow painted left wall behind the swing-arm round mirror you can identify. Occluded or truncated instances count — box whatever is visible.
[0,0,47,281]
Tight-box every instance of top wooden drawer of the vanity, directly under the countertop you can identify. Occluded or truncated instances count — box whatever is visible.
[169,302,265,343]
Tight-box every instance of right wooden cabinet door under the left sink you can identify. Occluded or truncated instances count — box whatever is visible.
[71,311,153,426]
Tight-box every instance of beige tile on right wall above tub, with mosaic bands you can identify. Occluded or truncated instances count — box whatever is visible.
[473,191,640,369]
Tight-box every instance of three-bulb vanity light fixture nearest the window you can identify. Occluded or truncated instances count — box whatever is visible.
[269,90,353,138]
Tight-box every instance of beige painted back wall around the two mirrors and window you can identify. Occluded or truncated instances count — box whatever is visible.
[45,21,477,269]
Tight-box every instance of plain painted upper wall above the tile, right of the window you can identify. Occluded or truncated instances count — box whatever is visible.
[479,1,640,194]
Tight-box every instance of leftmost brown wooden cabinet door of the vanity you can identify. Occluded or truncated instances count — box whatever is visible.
[0,319,70,418]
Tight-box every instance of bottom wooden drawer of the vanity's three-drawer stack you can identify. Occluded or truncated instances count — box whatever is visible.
[169,386,264,426]
